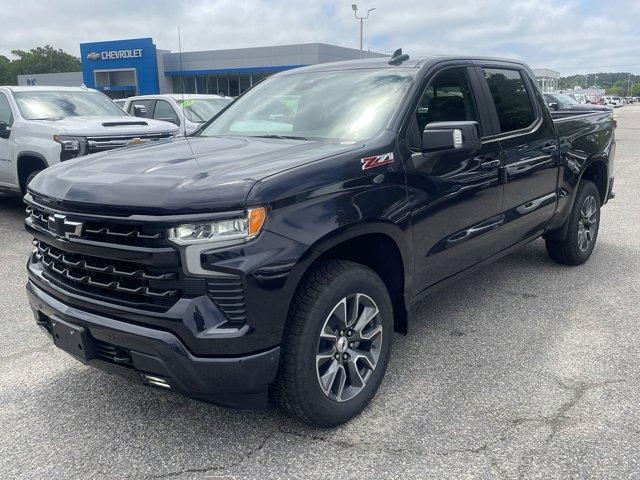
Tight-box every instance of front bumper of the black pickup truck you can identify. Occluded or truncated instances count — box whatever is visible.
[27,281,280,409]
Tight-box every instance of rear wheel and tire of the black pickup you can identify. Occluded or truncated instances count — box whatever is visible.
[546,180,602,265]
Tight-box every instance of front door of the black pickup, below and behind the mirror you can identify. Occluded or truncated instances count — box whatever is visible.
[406,66,503,294]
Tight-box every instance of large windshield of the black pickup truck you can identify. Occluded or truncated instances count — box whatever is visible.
[200,69,415,141]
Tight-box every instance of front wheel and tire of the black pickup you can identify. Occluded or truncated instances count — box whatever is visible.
[274,260,393,427]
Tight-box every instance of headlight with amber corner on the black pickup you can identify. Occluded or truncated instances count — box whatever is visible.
[167,207,267,245]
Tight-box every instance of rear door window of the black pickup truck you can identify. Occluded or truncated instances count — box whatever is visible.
[482,68,536,133]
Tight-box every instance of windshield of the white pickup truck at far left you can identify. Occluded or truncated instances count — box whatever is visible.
[14,90,126,120]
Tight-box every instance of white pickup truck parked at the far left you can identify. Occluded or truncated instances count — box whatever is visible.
[0,86,178,193]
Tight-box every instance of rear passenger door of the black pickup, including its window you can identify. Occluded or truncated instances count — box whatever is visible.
[477,64,560,248]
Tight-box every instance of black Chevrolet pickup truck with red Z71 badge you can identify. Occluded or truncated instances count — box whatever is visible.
[25,52,615,426]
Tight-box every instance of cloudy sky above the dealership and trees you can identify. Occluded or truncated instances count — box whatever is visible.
[0,0,640,75]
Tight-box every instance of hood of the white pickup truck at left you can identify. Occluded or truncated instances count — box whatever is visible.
[37,115,178,137]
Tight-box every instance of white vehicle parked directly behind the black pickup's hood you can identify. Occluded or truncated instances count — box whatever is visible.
[124,94,233,135]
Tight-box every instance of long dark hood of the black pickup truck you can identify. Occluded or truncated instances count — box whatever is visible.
[29,137,361,214]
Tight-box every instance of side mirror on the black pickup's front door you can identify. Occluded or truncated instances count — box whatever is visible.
[422,122,482,154]
